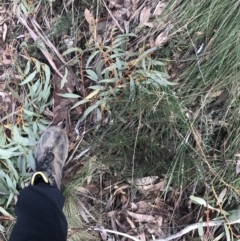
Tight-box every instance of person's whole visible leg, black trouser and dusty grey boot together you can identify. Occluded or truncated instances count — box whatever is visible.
[9,127,68,241]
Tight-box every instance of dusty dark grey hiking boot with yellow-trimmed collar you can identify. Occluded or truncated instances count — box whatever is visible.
[31,126,68,189]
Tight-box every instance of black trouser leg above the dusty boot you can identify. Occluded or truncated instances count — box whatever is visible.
[9,182,67,241]
